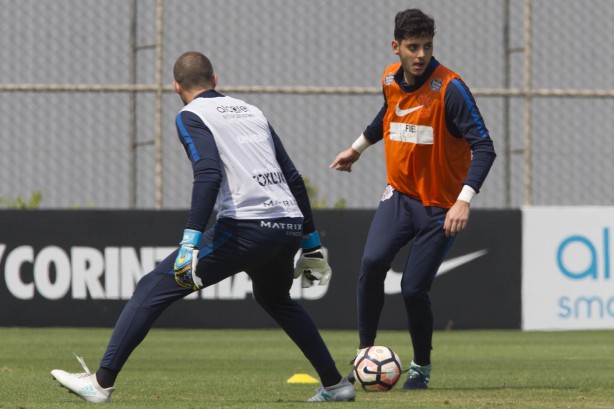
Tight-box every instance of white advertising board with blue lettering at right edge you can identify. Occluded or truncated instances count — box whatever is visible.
[522,207,614,330]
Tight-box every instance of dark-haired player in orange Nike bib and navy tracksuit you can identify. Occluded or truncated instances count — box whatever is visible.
[330,9,496,389]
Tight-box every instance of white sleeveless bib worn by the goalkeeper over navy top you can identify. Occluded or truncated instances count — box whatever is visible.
[184,96,302,219]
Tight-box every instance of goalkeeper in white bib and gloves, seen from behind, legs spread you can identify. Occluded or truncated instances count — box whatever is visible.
[51,52,355,402]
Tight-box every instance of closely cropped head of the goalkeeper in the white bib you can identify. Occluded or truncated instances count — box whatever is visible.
[173,51,213,91]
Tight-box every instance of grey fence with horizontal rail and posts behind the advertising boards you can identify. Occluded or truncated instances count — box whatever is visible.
[0,0,614,209]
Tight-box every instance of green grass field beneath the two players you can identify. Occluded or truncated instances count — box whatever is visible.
[0,328,614,409]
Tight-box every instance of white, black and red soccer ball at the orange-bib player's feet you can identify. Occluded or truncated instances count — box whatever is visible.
[354,346,401,392]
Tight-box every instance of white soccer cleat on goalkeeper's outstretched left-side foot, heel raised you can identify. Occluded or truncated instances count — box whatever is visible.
[51,353,115,403]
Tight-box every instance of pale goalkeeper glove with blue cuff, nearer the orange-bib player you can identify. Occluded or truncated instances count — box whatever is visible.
[294,231,332,288]
